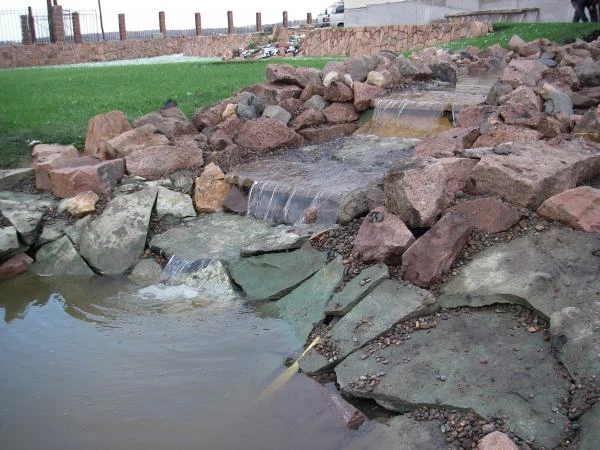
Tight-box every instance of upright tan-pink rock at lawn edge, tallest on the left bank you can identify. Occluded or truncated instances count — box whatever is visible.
[83,111,131,159]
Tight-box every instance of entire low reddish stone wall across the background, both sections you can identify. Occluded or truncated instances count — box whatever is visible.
[0,22,492,68]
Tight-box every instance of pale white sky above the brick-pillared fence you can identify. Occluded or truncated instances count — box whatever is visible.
[0,0,333,32]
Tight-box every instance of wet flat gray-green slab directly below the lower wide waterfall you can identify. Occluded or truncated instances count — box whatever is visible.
[150,213,273,261]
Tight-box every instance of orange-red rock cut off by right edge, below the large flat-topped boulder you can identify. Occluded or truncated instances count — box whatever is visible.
[537,186,600,234]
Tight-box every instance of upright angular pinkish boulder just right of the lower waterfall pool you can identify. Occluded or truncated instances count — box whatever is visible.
[383,158,447,228]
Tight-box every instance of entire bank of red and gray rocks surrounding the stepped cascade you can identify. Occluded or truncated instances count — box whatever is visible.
[0,31,600,448]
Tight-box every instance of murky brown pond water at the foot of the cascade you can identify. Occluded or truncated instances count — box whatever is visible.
[0,277,377,450]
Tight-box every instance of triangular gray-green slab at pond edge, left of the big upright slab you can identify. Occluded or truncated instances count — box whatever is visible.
[28,236,94,276]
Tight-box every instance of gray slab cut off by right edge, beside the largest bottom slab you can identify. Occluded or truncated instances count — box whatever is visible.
[550,302,600,384]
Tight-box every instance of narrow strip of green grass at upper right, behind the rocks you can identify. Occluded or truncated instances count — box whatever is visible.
[440,23,600,50]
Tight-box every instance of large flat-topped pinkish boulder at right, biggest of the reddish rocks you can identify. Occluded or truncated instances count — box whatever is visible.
[468,141,600,209]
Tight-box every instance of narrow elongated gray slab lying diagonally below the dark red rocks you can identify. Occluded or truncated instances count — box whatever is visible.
[325,264,390,316]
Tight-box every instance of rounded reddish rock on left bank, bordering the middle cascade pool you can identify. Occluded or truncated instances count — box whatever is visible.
[235,118,304,153]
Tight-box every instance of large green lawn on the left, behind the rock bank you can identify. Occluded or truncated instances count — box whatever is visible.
[0,58,327,168]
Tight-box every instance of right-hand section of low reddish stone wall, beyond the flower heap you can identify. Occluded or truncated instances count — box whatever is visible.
[301,22,492,56]
